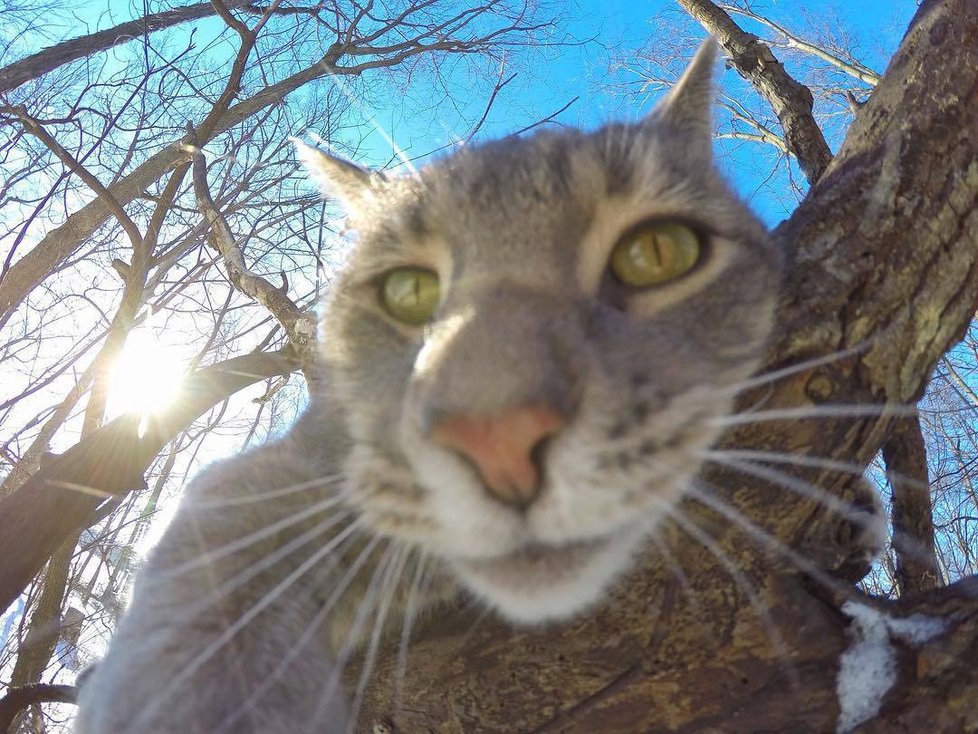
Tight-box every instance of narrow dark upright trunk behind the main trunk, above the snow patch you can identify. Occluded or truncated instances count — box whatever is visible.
[883,418,941,594]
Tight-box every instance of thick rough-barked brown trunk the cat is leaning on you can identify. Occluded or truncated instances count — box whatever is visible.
[349,0,978,734]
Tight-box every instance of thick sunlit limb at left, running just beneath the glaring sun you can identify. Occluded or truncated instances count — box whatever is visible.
[0,350,298,610]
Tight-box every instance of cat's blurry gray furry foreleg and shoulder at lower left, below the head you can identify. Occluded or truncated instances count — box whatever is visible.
[75,439,357,734]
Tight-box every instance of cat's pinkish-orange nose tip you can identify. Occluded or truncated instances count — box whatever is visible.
[431,405,565,510]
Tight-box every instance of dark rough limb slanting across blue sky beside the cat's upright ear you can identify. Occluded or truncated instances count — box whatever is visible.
[678,0,832,184]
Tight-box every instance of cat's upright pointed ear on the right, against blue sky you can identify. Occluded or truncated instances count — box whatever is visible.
[650,38,717,159]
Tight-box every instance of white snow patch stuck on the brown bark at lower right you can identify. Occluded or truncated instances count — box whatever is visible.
[835,601,947,734]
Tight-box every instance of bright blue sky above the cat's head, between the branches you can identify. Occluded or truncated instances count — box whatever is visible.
[38,0,917,225]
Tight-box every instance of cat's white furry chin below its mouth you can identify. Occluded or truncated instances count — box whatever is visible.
[454,528,642,625]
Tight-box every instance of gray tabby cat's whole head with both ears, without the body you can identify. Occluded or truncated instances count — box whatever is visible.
[304,43,780,622]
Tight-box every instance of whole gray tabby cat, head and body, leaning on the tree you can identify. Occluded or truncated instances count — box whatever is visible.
[76,43,781,734]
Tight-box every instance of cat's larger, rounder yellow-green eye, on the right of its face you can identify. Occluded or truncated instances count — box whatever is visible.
[610,222,701,288]
